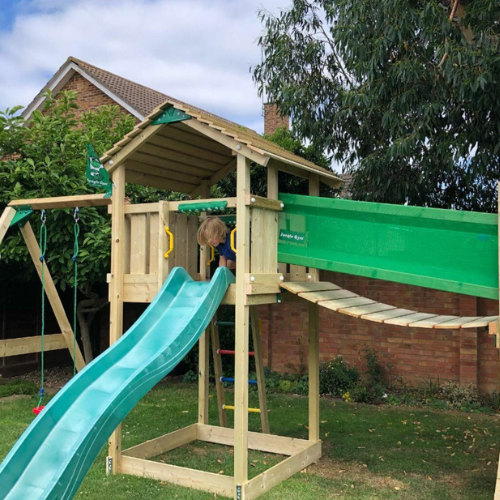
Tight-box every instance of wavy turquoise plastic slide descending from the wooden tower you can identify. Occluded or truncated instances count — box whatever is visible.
[0,267,234,500]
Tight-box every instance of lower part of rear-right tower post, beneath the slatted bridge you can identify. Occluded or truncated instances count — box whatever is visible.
[309,302,319,441]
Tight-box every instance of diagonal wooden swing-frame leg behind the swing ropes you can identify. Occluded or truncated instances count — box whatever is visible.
[21,222,85,370]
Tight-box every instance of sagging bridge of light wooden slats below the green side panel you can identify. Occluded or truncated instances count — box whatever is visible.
[280,281,498,329]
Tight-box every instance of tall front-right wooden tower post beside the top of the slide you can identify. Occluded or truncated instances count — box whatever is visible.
[234,154,250,500]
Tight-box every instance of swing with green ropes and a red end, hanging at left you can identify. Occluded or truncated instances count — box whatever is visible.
[33,207,80,415]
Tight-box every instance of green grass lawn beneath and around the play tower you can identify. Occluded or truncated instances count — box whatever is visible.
[0,379,499,500]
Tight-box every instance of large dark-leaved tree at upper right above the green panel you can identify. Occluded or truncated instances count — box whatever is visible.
[253,0,500,211]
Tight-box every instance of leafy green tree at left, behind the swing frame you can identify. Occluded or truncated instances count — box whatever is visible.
[0,92,134,362]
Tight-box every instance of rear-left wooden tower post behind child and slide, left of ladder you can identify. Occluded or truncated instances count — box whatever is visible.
[198,183,210,424]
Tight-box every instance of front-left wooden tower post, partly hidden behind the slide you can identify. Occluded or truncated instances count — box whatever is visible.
[106,164,125,474]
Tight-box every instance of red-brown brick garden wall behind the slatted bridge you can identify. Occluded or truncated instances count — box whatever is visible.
[259,272,499,392]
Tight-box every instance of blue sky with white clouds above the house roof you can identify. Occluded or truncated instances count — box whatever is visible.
[0,0,291,132]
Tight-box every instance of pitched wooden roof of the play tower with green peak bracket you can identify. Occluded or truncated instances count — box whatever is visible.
[101,98,342,197]
